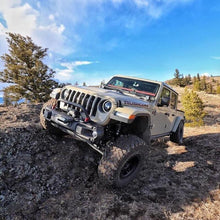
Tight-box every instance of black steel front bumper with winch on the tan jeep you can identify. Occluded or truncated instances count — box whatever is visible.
[44,107,104,143]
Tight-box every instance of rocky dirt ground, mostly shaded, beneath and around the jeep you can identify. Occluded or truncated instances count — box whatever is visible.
[0,104,220,220]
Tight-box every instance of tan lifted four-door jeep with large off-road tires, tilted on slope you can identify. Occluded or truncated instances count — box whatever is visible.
[40,76,184,187]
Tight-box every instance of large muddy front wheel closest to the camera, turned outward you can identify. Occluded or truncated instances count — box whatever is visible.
[98,135,146,187]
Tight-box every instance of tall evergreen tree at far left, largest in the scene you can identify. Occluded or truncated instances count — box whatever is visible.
[0,33,58,102]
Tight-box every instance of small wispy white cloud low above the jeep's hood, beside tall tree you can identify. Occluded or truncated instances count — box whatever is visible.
[55,61,94,82]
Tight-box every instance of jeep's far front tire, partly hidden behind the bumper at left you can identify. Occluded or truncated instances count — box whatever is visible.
[40,99,64,137]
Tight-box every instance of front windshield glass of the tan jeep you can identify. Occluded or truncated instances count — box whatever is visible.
[106,77,160,97]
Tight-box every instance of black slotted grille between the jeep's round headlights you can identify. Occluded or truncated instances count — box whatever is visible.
[62,90,101,116]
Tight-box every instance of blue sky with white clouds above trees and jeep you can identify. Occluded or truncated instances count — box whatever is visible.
[0,0,220,93]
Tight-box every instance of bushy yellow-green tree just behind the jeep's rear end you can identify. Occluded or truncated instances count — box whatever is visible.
[181,89,205,126]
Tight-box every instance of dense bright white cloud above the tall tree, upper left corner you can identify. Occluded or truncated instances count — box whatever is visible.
[0,0,68,55]
